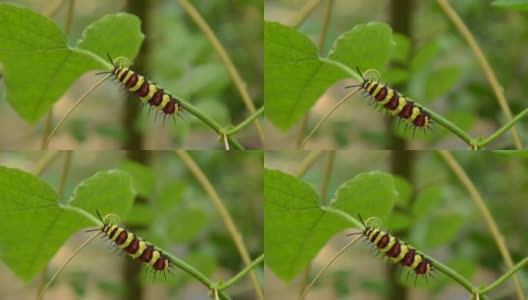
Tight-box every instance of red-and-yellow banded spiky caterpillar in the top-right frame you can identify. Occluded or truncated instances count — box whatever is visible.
[345,66,432,132]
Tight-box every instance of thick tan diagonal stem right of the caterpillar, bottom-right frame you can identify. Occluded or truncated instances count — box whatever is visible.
[438,150,524,299]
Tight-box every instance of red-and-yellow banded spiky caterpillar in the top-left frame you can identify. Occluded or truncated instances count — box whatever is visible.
[97,53,182,120]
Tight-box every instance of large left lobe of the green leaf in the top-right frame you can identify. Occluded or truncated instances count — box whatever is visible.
[264,22,351,130]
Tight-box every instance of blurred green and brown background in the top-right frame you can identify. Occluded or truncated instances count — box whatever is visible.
[264,0,528,149]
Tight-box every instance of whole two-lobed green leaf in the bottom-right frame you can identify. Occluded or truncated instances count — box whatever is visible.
[264,170,397,280]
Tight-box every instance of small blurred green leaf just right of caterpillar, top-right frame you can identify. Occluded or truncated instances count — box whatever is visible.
[421,66,460,103]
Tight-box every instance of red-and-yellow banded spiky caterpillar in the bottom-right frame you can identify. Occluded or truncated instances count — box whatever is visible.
[348,215,434,285]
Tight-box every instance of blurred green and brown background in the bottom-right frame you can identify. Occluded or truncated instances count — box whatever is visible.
[265,150,528,300]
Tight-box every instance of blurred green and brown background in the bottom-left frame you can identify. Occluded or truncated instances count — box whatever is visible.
[0,151,263,300]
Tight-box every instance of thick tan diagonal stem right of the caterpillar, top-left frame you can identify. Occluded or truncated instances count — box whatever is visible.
[179,0,264,145]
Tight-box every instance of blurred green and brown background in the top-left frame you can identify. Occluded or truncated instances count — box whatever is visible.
[0,0,263,149]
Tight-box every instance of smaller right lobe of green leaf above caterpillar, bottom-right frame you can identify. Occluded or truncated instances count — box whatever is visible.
[331,171,399,220]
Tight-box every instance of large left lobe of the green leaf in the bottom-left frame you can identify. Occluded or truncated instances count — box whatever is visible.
[0,166,85,282]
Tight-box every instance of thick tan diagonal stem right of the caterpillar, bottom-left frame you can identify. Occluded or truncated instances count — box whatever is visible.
[176,150,264,300]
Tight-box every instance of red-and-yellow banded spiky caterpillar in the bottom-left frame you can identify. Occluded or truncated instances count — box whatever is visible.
[88,211,173,278]
